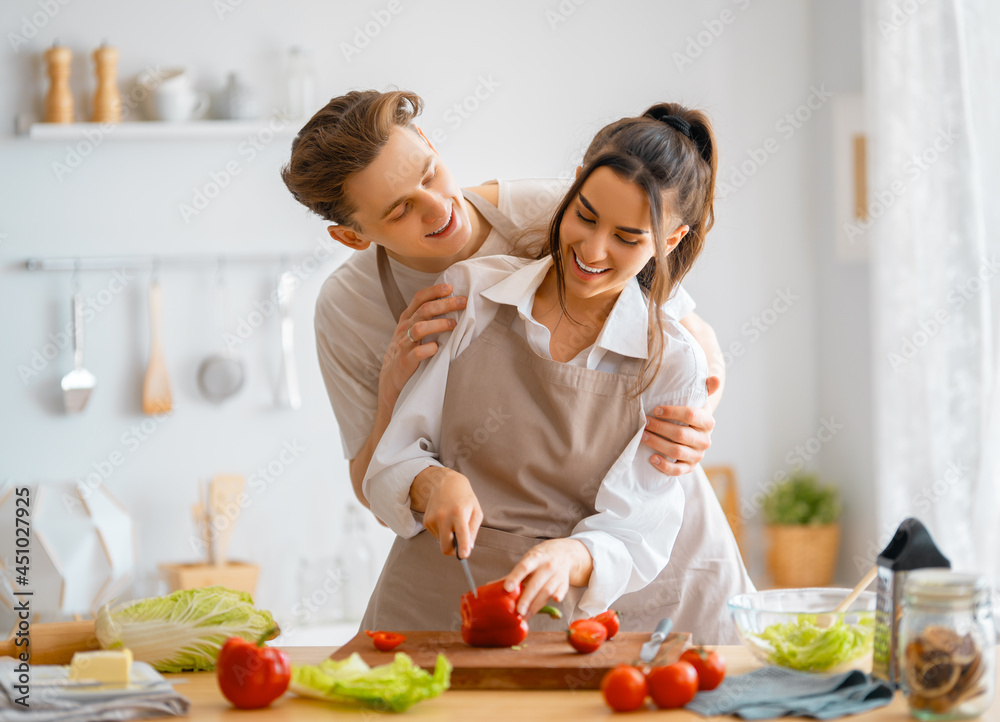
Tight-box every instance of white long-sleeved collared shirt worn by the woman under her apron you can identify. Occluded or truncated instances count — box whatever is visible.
[363,256,708,614]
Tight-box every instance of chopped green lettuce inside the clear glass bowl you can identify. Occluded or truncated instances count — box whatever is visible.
[759,614,875,672]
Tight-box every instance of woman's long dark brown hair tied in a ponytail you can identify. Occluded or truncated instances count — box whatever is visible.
[546,103,718,393]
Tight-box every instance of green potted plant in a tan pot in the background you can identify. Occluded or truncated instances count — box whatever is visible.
[764,473,840,587]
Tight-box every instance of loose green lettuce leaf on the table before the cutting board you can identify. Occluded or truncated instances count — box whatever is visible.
[288,652,451,712]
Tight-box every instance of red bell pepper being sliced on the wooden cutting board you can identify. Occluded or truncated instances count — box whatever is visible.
[462,579,562,647]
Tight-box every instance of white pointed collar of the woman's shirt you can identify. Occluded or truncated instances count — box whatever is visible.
[482,256,649,359]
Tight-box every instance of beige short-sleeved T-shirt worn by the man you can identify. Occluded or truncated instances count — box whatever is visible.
[315,178,694,459]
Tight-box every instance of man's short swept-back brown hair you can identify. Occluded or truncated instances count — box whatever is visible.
[281,90,423,230]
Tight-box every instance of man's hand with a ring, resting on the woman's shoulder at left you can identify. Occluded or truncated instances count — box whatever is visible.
[376,283,466,414]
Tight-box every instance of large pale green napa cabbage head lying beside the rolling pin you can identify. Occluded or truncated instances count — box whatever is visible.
[95,586,277,672]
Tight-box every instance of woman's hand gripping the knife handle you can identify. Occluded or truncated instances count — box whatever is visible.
[410,466,483,559]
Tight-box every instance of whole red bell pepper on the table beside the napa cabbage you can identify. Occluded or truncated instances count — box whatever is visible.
[215,632,292,709]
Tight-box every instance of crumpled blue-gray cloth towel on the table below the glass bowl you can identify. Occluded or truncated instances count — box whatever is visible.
[685,667,893,720]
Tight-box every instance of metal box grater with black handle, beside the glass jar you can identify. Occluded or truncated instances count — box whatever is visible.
[872,518,951,687]
